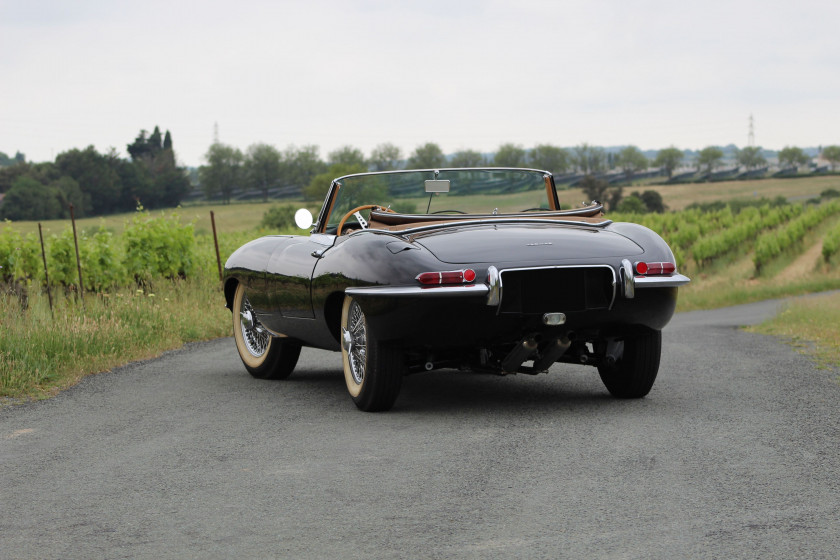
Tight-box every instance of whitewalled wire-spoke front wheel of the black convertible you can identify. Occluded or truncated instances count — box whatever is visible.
[233,284,300,379]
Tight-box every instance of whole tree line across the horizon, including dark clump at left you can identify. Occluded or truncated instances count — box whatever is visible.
[0,136,840,220]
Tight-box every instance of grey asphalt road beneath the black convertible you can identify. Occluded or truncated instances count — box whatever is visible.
[0,303,840,560]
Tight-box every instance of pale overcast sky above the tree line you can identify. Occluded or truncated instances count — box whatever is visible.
[0,0,840,165]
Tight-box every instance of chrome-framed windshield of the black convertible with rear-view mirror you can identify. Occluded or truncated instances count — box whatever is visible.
[322,169,556,230]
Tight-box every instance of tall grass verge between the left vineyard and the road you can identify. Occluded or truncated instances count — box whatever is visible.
[0,279,230,399]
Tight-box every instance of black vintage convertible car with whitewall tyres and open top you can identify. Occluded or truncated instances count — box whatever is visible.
[224,168,689,411]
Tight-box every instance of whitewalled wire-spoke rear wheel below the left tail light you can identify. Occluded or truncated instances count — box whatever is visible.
[341,296,405,412]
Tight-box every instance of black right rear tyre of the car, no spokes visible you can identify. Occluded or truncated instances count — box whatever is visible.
[598,330,662,399]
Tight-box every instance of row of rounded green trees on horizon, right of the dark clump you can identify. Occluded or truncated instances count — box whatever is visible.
[199,142,840,206]
